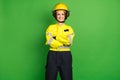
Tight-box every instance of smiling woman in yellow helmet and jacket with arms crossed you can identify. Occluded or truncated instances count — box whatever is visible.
[46,3,74,80]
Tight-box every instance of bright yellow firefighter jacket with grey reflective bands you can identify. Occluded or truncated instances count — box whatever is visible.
[46,24,74,51]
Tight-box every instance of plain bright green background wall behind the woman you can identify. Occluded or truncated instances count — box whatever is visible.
[0,0,120,80]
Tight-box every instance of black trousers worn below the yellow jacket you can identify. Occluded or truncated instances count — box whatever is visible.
[45,51,72,80]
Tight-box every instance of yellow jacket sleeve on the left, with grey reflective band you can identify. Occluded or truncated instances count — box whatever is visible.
[46,27,63,48]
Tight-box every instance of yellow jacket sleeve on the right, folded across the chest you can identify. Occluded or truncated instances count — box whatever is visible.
[56,27,74,46]
